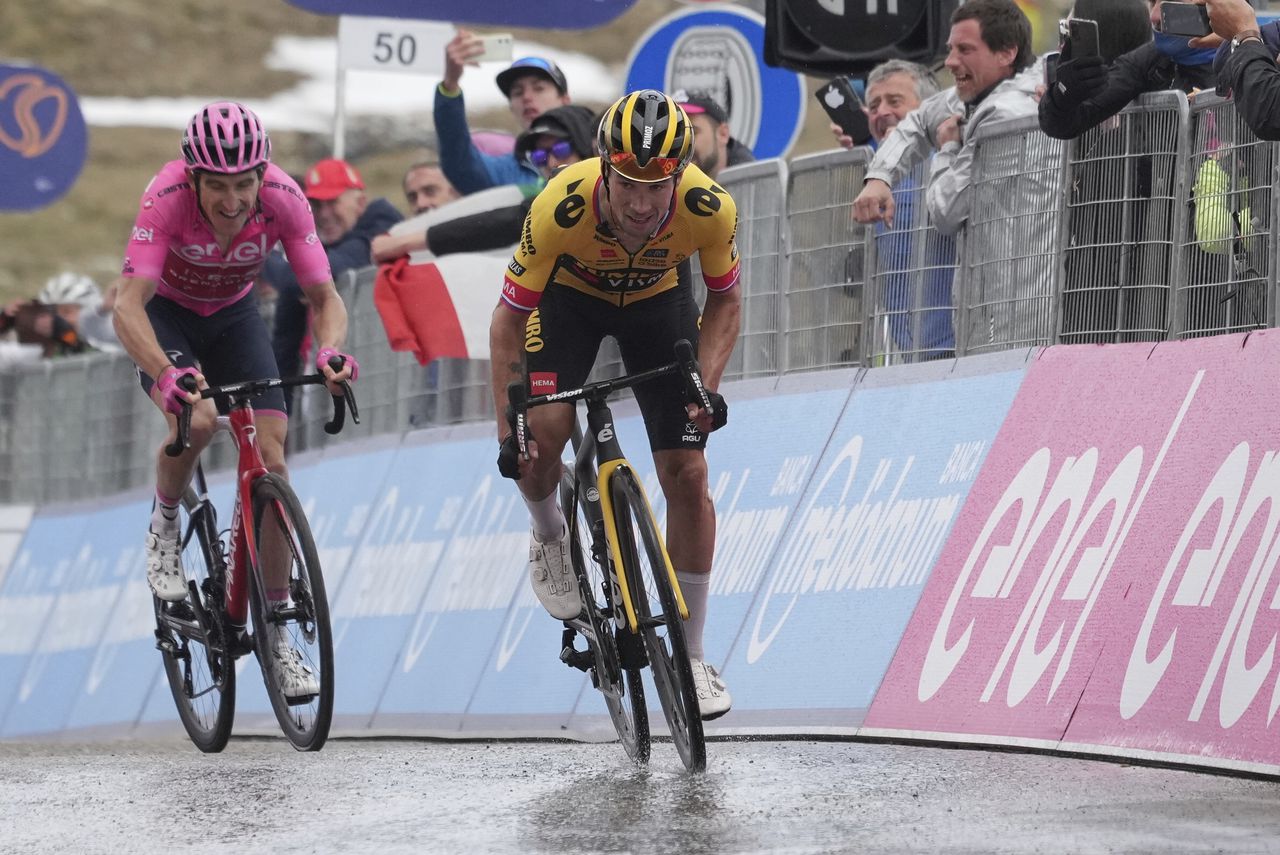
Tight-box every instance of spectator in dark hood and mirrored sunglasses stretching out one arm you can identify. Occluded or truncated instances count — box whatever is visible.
[372,104,596,264]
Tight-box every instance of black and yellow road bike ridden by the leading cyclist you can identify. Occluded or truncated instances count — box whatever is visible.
[507,339,712,772]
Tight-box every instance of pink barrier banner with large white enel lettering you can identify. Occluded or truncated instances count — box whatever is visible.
[865,330,1280,765]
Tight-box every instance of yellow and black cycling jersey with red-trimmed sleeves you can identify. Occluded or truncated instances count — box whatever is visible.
[502,157,739,312]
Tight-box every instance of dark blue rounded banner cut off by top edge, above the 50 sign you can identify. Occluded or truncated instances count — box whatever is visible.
[289,0,635,29]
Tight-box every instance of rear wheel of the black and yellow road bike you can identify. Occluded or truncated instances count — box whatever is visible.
[561,470,650,764]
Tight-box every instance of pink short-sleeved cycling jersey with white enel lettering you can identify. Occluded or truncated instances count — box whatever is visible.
[123,160,333,316]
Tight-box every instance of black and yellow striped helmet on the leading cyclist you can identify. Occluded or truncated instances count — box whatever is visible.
[595,90,694,183]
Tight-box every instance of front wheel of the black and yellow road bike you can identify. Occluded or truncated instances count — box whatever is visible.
[609,467,707,772]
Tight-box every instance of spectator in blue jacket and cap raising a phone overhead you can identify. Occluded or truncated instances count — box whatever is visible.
[434,29,570,195]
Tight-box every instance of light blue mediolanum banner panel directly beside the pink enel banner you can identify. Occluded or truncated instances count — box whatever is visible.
[724,370,1023,728]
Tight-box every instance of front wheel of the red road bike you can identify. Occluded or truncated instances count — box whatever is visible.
[250,474,333,751]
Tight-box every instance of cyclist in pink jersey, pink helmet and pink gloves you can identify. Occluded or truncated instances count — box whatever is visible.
[115,101,358,694]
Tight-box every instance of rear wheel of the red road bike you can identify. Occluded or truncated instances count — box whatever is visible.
[152,490,236,754]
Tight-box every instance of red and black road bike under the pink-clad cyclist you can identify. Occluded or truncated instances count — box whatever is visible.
[152,357,360,753]
